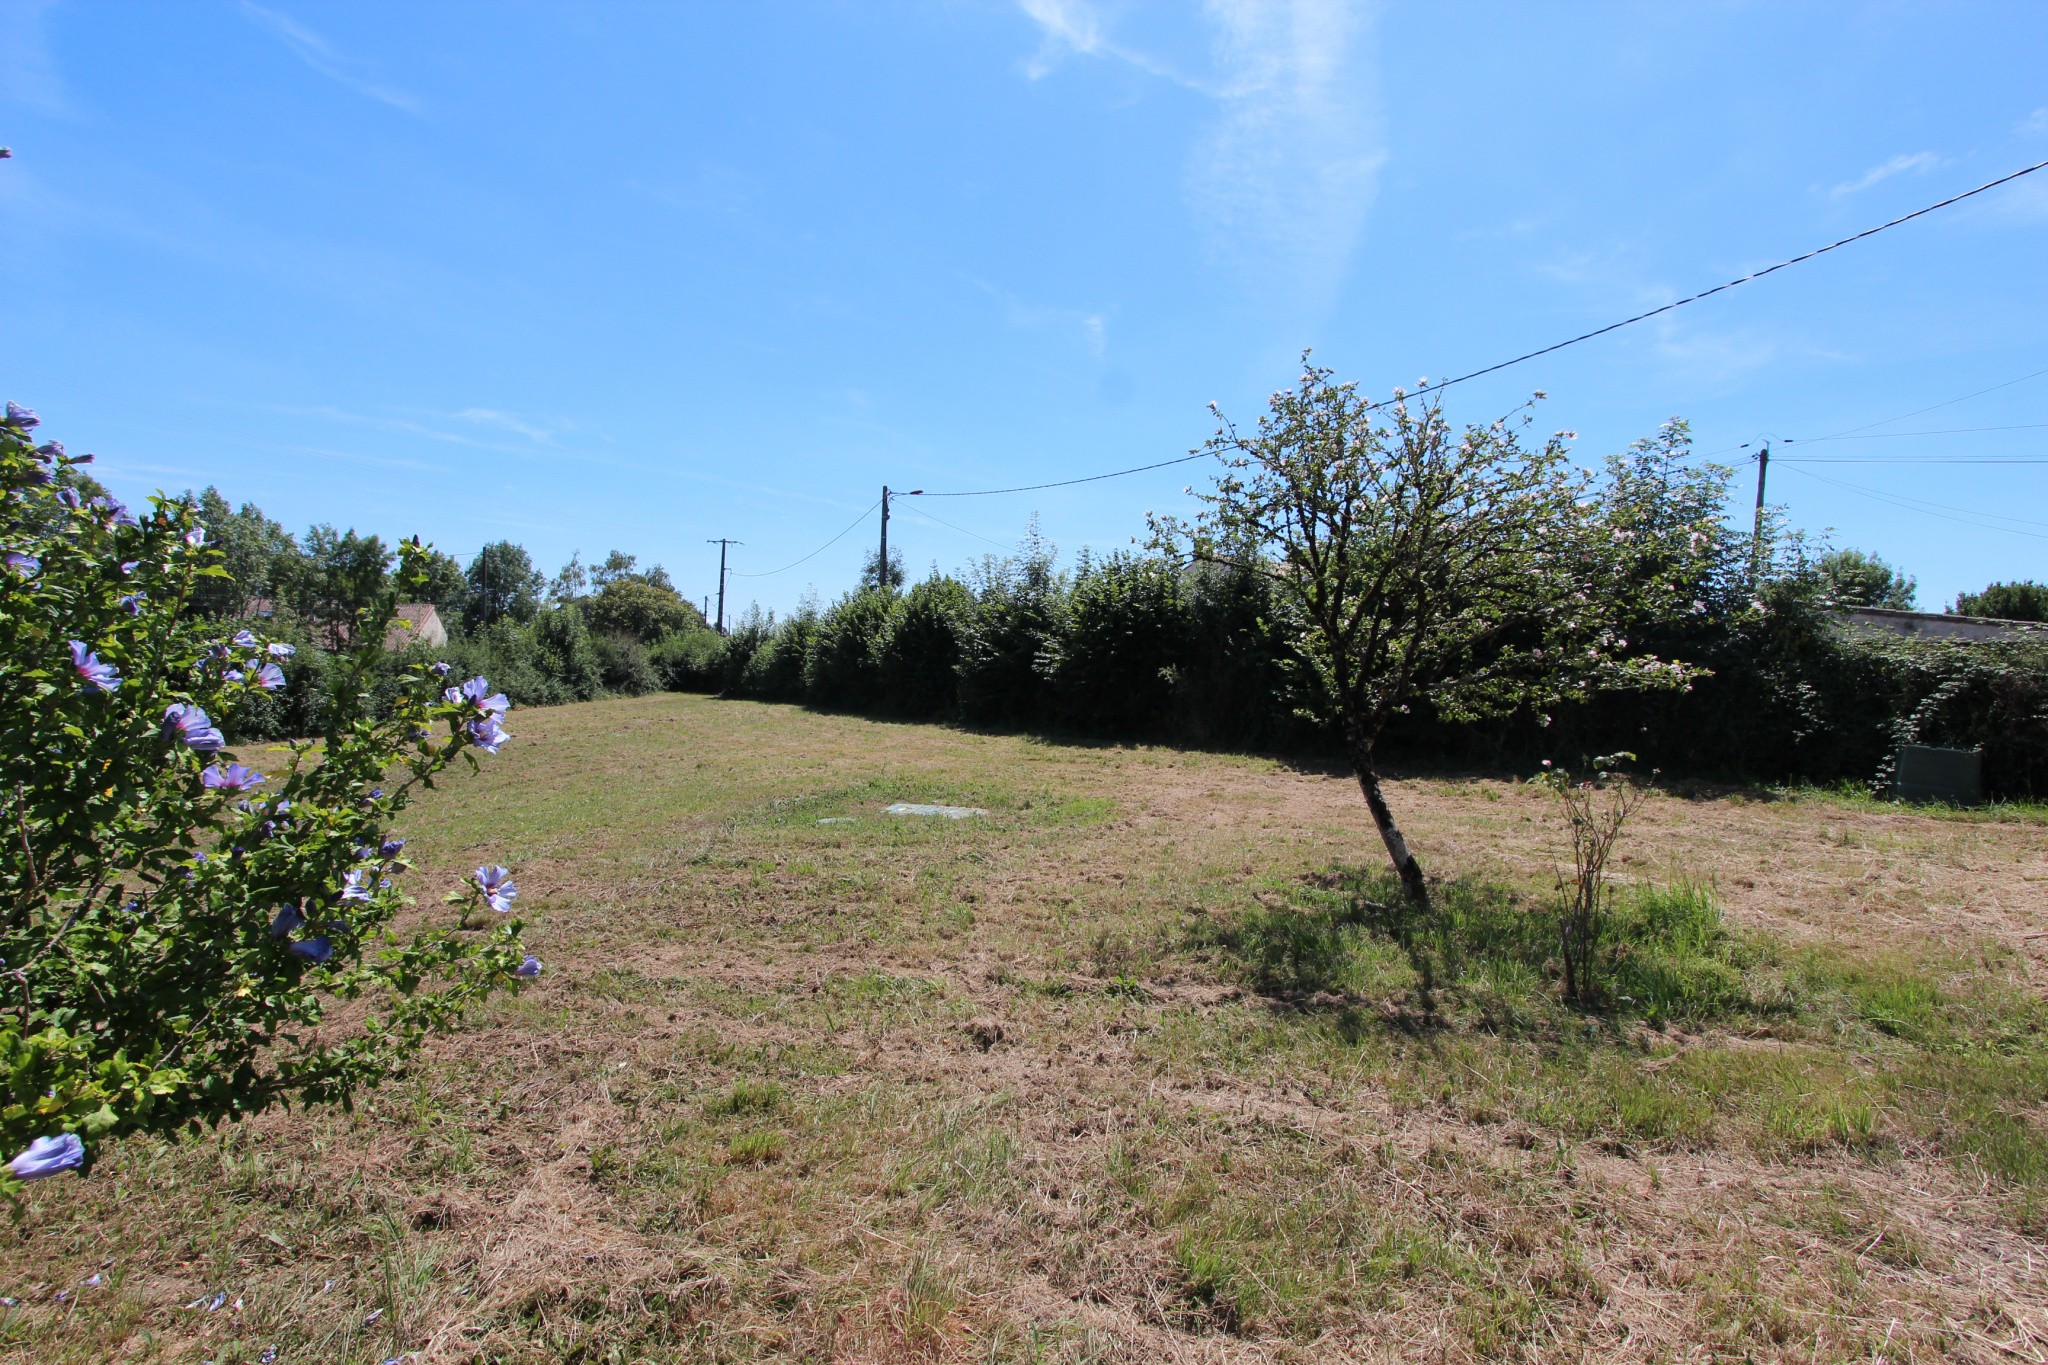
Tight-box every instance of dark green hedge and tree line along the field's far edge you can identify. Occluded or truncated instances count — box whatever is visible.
[44,422,2048,794]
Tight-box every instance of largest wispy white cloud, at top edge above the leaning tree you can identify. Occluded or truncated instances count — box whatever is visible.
[1018,0,1386,297]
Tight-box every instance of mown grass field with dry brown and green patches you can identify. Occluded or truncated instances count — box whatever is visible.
[0,696,2048,1365]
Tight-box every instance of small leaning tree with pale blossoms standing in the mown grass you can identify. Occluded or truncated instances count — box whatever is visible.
[1153,356,1690,909]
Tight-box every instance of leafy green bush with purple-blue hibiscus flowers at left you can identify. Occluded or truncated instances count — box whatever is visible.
[0,403,541,1195]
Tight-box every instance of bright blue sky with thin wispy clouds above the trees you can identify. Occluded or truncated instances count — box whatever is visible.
[0,0,2048,610]
